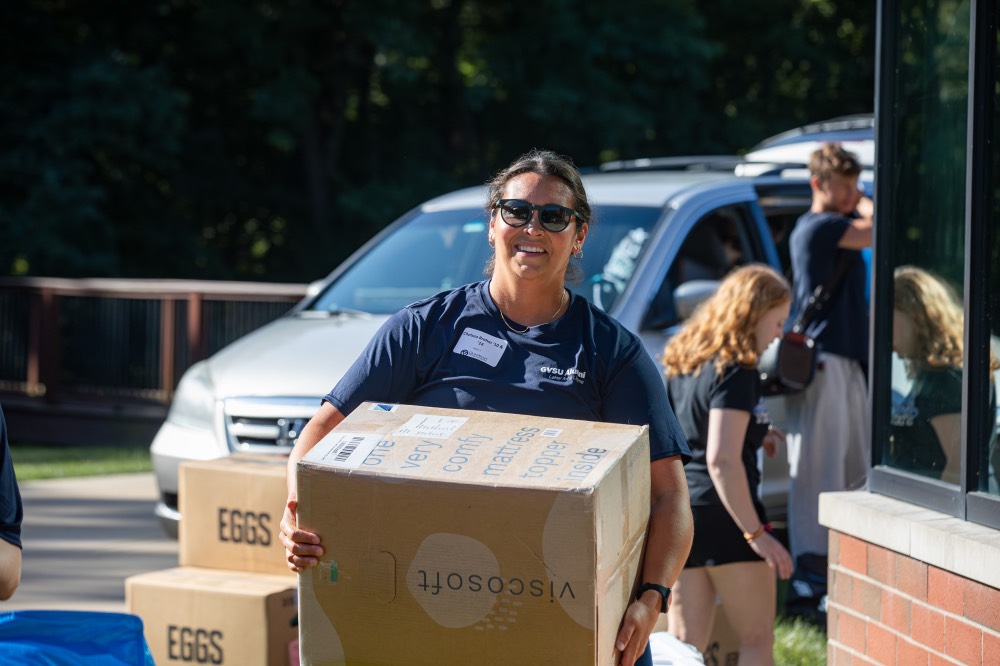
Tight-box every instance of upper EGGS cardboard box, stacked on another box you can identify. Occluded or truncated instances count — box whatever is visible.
[177,454,294,577]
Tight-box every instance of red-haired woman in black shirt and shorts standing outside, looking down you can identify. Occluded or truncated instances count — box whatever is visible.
[663,264,792,664]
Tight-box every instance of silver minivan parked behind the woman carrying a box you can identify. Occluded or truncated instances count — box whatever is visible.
[151,159,836,534]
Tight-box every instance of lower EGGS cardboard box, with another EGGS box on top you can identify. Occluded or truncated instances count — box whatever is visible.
[125,567,298,666]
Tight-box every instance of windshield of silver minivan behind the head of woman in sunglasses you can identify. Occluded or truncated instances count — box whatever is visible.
[311,206,661,314]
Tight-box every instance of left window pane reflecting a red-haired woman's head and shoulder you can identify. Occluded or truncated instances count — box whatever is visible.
[875,0,969,483]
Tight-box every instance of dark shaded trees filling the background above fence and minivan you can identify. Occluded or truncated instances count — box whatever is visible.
[0,0,874,281]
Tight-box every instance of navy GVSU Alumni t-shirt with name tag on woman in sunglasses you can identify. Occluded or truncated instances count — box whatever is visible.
[324,281,690,461]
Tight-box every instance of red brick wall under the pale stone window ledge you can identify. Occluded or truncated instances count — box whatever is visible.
[827,530,1000,666]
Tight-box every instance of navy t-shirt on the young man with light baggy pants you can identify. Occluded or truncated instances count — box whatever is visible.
[788,211,868,364]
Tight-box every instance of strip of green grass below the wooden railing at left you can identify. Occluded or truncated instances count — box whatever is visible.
[10,443,153,482]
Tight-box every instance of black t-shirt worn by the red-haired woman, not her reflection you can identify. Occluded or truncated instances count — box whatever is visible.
[667,359,771,508]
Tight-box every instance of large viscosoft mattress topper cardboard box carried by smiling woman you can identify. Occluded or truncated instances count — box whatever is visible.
[297,403,649,666]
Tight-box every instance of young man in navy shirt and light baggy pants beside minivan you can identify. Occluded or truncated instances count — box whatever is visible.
[788,144,874,603]
